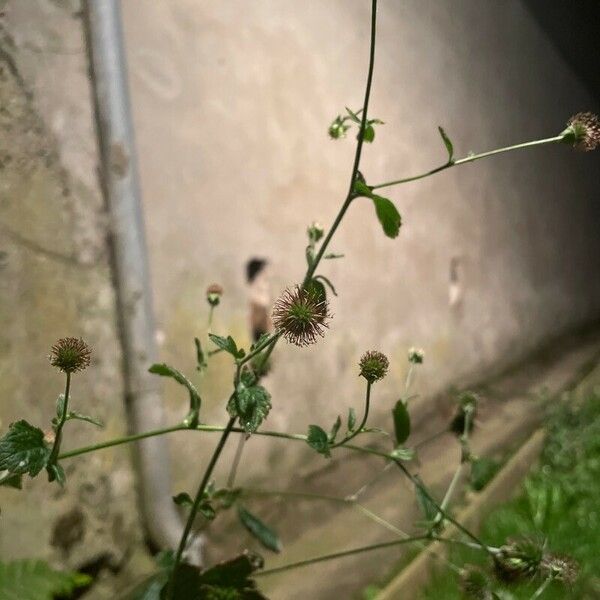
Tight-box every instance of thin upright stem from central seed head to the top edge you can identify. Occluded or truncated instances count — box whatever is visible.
[302,0,377,286]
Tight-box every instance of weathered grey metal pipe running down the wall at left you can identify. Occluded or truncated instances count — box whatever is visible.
[85,0,199,560]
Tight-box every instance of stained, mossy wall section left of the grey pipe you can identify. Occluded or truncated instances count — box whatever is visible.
[0,2,149,599]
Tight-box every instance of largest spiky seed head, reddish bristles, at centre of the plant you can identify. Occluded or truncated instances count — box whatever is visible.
[272,285,331,346]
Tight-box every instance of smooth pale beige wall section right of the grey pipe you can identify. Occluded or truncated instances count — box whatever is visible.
[118,0,600,487]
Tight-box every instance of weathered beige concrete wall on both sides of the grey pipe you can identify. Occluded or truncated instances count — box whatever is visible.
[0,0,600,596]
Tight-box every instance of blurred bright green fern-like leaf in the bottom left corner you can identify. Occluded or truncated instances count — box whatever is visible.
[0,560,92,600]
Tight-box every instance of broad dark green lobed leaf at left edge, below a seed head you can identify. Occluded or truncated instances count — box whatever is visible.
[0,421,50,477]
